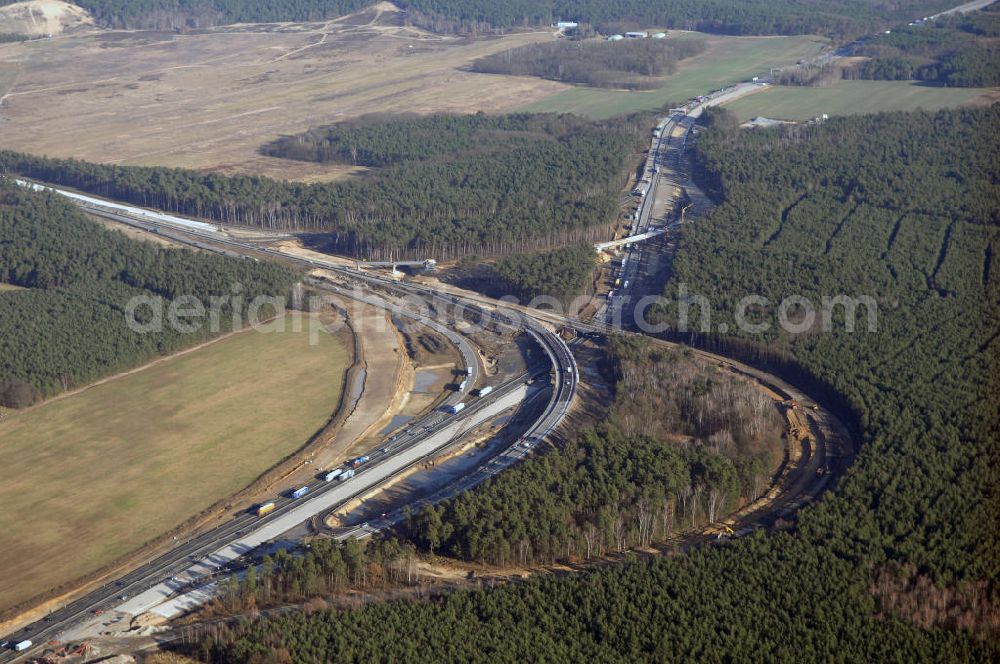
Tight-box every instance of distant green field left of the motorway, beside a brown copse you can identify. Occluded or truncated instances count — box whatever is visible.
[521,33,827,118]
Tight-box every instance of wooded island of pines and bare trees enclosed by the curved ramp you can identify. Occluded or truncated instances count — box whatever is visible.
[403,337,784,567]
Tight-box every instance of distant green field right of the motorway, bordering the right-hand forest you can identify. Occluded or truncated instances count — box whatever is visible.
[726,81,991,120]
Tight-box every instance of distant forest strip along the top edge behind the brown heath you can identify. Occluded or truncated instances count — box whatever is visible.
[0,0,954,37]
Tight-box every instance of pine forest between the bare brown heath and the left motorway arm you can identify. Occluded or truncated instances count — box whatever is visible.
[0,114,650,260]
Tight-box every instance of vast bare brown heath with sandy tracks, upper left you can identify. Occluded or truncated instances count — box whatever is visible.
[0,4,566,181]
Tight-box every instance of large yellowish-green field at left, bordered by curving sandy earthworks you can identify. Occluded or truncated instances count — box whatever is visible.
[0,316,350,609]
